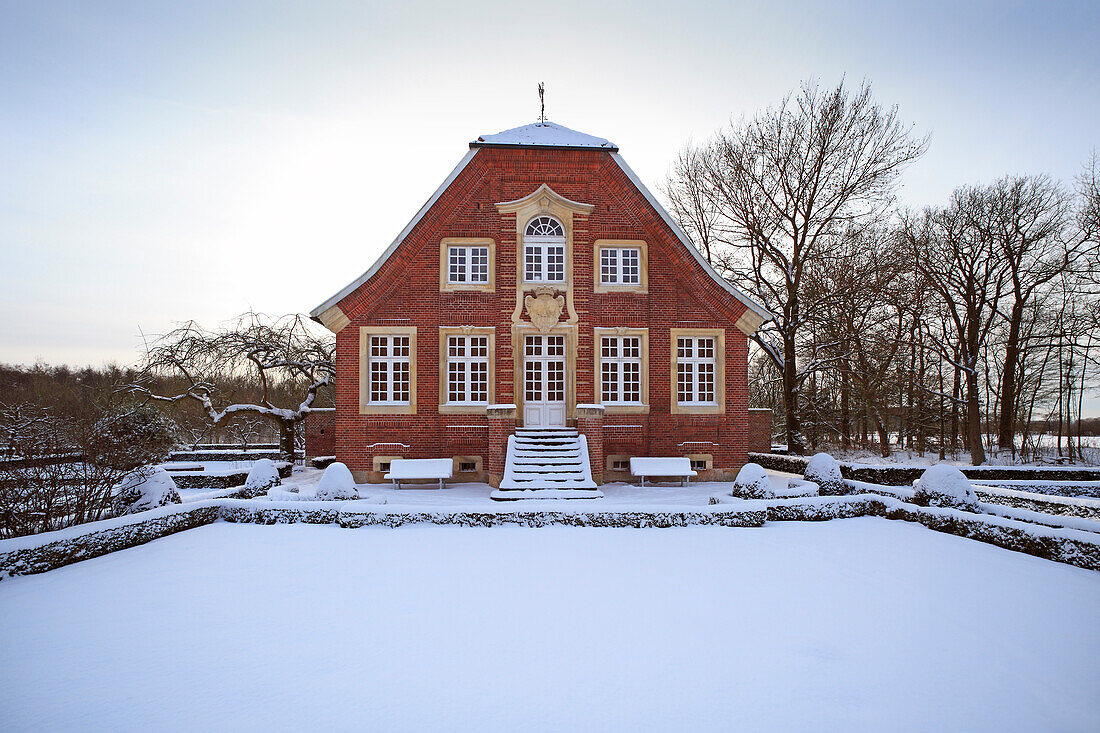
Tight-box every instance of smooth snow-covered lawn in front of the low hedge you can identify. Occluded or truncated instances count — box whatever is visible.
[0,517,1100,731]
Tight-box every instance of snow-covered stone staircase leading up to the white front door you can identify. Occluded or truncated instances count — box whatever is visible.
[490,428,604,501]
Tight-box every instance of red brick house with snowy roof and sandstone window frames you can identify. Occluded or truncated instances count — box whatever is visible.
[311,122,770,497]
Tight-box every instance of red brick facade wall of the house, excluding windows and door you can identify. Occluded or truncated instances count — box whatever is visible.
[325,147,748,474]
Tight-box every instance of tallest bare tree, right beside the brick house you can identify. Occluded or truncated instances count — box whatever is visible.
[668,81,926,453]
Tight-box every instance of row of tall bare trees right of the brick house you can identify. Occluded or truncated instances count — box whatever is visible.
[664,77,1100,464]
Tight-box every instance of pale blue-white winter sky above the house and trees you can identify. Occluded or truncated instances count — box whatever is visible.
[0,0,1100,400]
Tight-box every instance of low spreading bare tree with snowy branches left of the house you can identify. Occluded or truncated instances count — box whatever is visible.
[131,313,336,460]
